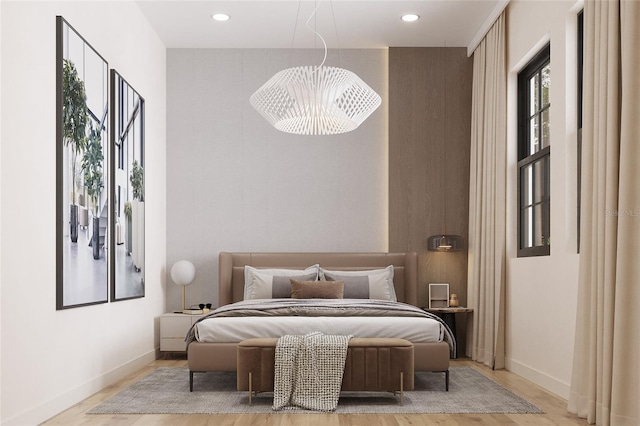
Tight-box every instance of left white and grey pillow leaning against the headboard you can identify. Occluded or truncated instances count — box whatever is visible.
[244,264,319,300]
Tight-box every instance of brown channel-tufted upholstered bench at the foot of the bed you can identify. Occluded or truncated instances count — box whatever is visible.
[237,338,413,404]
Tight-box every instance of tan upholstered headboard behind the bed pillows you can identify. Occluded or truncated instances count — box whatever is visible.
[218,252,418,306]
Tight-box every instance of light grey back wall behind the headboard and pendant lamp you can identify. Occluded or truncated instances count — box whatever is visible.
[167,49,388,310]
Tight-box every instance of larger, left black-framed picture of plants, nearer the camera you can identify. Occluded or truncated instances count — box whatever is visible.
[56,16,111,310]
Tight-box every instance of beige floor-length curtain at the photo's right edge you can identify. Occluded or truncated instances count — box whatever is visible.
[569,0,640,426]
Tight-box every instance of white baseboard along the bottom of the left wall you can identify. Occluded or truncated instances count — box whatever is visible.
[2,349,156,426]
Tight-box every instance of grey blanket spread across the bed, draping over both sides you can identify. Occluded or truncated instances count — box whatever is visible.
[185,299,456,354]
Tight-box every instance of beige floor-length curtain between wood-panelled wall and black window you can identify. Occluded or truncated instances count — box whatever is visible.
[466,13,507,368]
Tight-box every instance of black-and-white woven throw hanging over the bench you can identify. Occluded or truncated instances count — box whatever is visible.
[273,332,352,411]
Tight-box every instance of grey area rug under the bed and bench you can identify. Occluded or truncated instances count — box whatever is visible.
[89,367,543,414]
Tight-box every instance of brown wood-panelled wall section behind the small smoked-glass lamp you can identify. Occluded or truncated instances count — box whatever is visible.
[389,47,473,353]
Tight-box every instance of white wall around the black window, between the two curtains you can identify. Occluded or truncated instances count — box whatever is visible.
[506,0,579,398]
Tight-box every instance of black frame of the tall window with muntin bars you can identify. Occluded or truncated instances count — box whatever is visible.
[517,44,551,257]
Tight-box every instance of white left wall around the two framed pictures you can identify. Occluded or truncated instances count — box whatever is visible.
[0,1,166,424]
